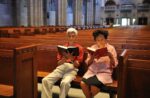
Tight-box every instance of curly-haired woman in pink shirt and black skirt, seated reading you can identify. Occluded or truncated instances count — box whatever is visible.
[80,30,118,98]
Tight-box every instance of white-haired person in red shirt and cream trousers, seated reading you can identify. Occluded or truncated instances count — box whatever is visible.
[42,28,84,98]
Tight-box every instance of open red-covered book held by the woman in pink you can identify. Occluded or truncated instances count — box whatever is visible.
[87,47,108,58]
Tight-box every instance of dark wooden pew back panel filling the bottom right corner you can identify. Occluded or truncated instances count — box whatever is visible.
[124,59,150,98]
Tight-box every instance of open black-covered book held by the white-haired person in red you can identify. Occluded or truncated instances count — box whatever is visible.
[57,45,79,56]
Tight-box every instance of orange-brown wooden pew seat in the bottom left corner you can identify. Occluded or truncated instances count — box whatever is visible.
[0,84,13,98]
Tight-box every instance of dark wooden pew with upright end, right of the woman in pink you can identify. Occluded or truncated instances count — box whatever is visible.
[118,50,150,98]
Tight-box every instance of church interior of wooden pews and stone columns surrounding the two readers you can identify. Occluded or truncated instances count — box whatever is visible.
[0,0,150,98]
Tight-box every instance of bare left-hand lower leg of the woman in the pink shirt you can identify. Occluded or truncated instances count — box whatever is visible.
[80,81,92,98]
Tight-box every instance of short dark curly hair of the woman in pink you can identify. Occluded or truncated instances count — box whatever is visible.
[93,30,109,40]
